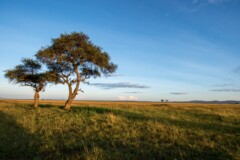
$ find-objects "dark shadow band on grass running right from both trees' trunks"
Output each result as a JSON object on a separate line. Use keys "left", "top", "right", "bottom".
{"left": 36, "top": 104, "right": 240, "bottom": 134}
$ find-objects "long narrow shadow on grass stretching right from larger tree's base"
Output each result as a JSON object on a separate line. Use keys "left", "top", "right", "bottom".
{"left": 71, "top": 107, "right": 240, "bottom": 134}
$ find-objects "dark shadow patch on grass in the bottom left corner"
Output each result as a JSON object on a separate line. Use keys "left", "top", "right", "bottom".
{"left": 0, "top": 112, "right": 38, "bottom": 160}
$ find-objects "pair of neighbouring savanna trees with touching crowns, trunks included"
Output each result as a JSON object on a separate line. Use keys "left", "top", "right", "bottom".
{"left": 5, "top": 32, "right": 117, "bottom": 109}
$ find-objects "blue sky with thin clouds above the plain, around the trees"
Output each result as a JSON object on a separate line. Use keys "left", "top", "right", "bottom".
{"left": 0, "top": 0, "right": 240, "bottom": 101}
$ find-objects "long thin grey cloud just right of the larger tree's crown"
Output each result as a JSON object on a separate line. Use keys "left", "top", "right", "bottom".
{"left": 90, "top": 82, "right": 150, "bottom": 89}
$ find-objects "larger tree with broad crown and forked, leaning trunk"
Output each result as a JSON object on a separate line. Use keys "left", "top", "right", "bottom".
{"left": 36, "top": 32, "right": 117, "bottom": 109}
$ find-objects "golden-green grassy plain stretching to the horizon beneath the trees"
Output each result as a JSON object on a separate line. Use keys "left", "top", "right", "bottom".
{"left": 0, "top": 100, "right": 240, "bottom": 160}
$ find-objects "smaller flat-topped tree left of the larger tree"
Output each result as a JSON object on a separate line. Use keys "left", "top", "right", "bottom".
{"left": 5, "top": 58, "right": 49, "bottom": 107}
